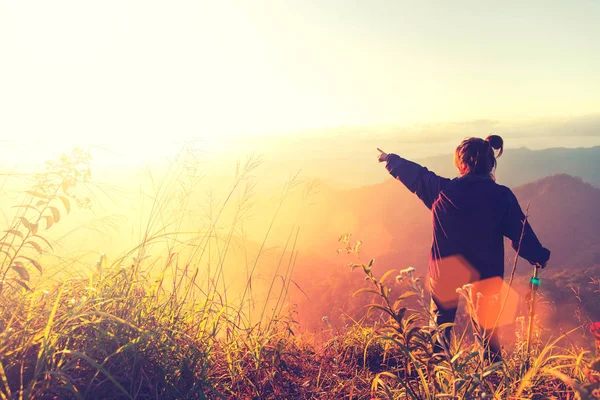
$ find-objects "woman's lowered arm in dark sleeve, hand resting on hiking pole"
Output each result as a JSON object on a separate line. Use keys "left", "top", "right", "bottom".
{"left": 502, "top": 188, "right": 550, "bottom": 267}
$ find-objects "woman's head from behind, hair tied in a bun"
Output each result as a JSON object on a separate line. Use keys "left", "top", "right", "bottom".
{"left": 454, "top": 135, "right": 504, "bottom": 176}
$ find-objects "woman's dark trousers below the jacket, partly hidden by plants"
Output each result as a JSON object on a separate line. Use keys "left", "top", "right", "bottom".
{"left": 431, "top": 295, "right": 502, "bottom": 362}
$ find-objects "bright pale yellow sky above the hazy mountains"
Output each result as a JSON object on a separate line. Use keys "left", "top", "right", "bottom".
{"left": 0, "top": 0, "right": 600, "bottom": 166}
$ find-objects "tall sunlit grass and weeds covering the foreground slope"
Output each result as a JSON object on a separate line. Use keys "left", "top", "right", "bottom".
{"left": 0, "top": 151, "right": 600, "bottom": 399}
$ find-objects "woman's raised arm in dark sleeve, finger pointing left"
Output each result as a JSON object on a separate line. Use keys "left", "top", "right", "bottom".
{"left": 377, "top": 149, "right": 450, "bottom": 210}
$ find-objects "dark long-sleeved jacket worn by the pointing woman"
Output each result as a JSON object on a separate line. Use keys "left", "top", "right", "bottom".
{"left": 386, "top": 154, "right": 550, "bottom": 279}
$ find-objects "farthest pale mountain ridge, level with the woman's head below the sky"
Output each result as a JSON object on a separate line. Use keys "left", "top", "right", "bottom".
{"left": 245, "top": 145, "right": 600, "bottom": 188}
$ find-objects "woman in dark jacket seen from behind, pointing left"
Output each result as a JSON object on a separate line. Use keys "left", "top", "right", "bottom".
{"left": 377, "top": 135, "right": 550, "bottom": 361}
